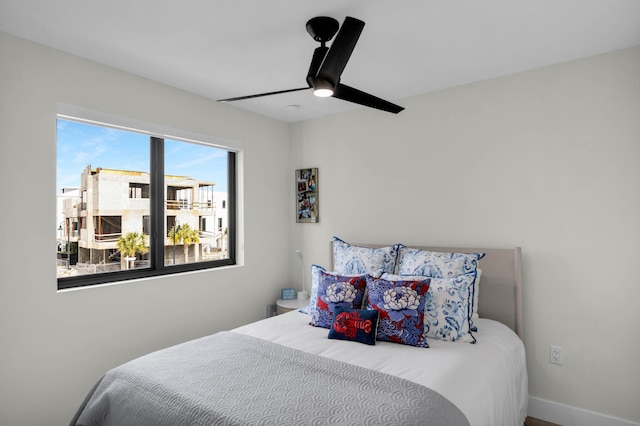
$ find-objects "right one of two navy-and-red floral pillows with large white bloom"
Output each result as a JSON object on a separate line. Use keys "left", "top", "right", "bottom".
{"left": 367, "top": 275, "right": 430, "bottom": 348}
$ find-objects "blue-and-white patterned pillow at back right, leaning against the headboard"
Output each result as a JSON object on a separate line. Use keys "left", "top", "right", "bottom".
{"left": 396, "top": 247, "right": 484, "bottom": 278}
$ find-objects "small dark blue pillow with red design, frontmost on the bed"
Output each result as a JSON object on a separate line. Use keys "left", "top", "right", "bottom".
{"left": 329, "top": 306, "right": 379, "bottom": 345}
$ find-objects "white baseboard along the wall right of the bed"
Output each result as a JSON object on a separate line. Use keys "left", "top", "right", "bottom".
{"left": 527, "top": 396, "right": 640, "bottom": 426}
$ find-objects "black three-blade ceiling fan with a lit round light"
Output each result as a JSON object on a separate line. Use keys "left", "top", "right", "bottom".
{"left": 218, "top": 16, "right": 404, "bottom": 114}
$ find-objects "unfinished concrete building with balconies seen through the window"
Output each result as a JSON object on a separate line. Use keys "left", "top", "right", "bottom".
{"left": 58, "top": 165, "right": 227, "bottom": 273}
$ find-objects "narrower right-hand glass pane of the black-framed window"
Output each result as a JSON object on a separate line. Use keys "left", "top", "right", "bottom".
{"left": 163, "top": 139, "right": 229, "bottom": 265}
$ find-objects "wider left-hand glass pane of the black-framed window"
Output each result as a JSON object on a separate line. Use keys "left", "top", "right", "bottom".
{"left": 56, "top": 119, "right": 150, "bottom": 278}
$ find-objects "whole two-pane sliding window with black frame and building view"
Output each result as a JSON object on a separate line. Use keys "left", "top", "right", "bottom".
{"left": 56, "top": 116, "right": 236, "bottom": 289}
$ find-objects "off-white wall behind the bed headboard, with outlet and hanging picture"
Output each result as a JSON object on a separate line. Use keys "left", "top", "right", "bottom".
{"left": 292, "top": 48, "right": 640, "bottom": 422}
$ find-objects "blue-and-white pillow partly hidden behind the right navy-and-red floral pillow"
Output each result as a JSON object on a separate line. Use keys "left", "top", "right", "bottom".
{"left": 381, "top": 273, "right": 478, "bottom": 343}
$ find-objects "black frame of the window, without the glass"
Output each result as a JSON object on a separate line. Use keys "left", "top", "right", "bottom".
{"left": 57, "top": 131, "right": 237, "bottom": 290}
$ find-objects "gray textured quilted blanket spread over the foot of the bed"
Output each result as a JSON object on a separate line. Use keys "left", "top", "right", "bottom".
{"left": 71, "top": 332, "right": 469, "bottom": 426}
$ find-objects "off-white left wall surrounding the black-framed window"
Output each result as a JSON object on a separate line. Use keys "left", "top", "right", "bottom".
{"left": 0, "top": 34, "right": 293, "bottom": 426}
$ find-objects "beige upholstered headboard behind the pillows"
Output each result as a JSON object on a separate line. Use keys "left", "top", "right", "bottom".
{"left": 331, "top": 244, "right": 524, "bottom": 340}
